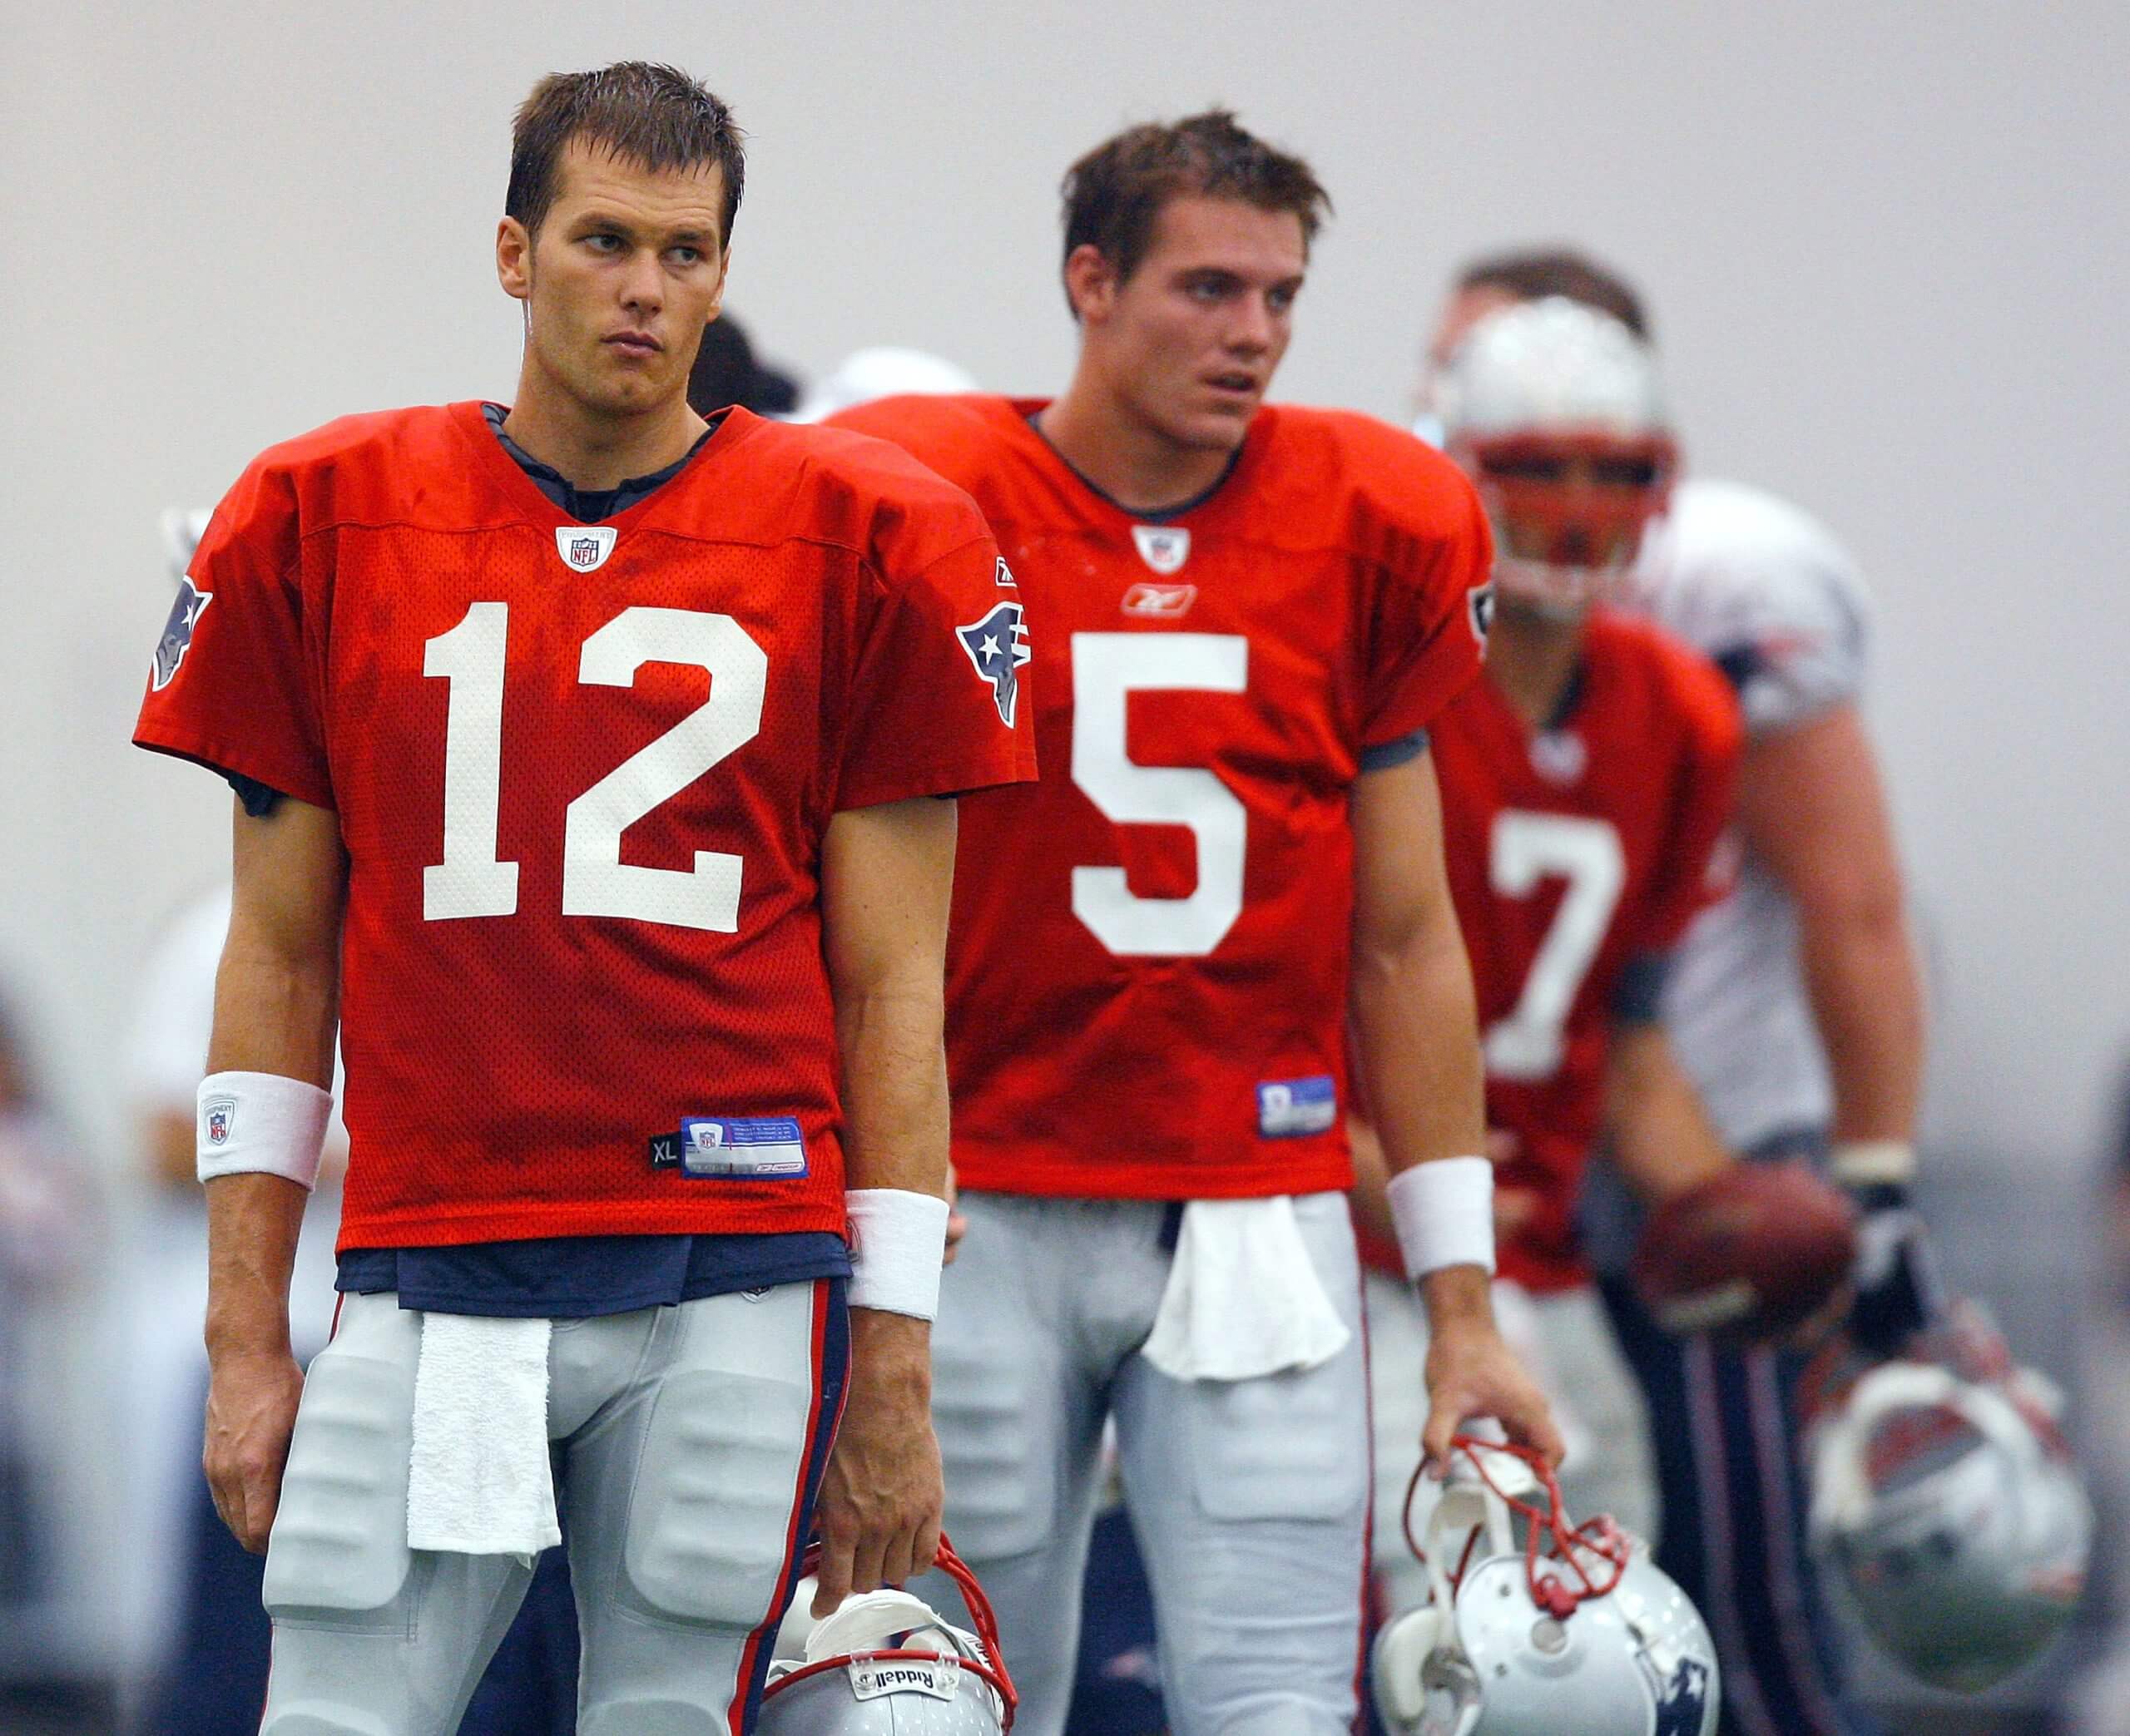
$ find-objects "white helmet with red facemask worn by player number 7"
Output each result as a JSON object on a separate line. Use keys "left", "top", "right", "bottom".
{"left": 1427, "top": 296, "right": 1678, "bottom": 618}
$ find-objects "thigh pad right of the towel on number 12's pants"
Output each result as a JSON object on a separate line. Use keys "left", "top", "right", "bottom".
{"left": 622, "top": 1370, "right": 814, "bottom": 1627}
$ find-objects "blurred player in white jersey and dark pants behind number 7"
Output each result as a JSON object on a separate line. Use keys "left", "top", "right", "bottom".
{"left": 1429, "top": 251, "right": 1934, "bottom": 1736}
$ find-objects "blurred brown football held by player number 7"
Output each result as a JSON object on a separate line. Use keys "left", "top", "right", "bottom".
{"left": 1632, "top": 1163, "right": 1857, "bottom": 1344}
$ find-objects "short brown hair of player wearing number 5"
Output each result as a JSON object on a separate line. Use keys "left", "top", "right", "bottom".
{"left": 1058, "top": 109, "right": 1331, "bottom": 315}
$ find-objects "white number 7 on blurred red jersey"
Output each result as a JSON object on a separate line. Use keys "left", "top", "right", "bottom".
{"left": 1487, "top": 809, "right": 1627, "bottom": 1080}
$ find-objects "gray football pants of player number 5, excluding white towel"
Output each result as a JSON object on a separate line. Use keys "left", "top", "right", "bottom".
{"left": 918, "top": 1193, "right": 1370, "bottom": 1736}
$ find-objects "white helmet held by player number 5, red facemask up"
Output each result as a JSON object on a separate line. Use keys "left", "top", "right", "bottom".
{"left": 1372, "top": 1436, "right": 1721, "bottom": 1736}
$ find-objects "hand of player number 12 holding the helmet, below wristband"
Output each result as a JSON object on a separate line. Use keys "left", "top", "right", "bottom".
{"left": 814, "top": 1308, "right": 946, "bottom": 1619}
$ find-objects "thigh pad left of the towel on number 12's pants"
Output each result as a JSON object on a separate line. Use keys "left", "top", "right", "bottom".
{"left": 264, "top": 1353, "right": 414, "bottom": 1619}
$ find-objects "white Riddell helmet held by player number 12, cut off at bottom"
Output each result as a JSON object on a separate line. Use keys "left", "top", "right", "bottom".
{"left": 754, "top": 1538, "right": 1016, "bottom": 1736}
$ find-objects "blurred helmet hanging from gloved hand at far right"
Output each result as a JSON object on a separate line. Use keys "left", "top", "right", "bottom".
{"left": 1806, "top": 1303, "right": 2093, "bottom": 1694}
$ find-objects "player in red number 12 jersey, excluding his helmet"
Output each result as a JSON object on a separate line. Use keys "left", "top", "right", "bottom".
{"left": 136, "top": 62, "right": 1033, "bottom": 1736}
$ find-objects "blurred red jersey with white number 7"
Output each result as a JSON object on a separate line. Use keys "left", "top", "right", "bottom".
{"left": 1435, "top": 613, "right": 1741, "bottom": 1291}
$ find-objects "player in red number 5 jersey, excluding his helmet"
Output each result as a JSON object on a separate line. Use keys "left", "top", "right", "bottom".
{"left": 835, "top": 113, "right": 1555, "bottom": 1736}
